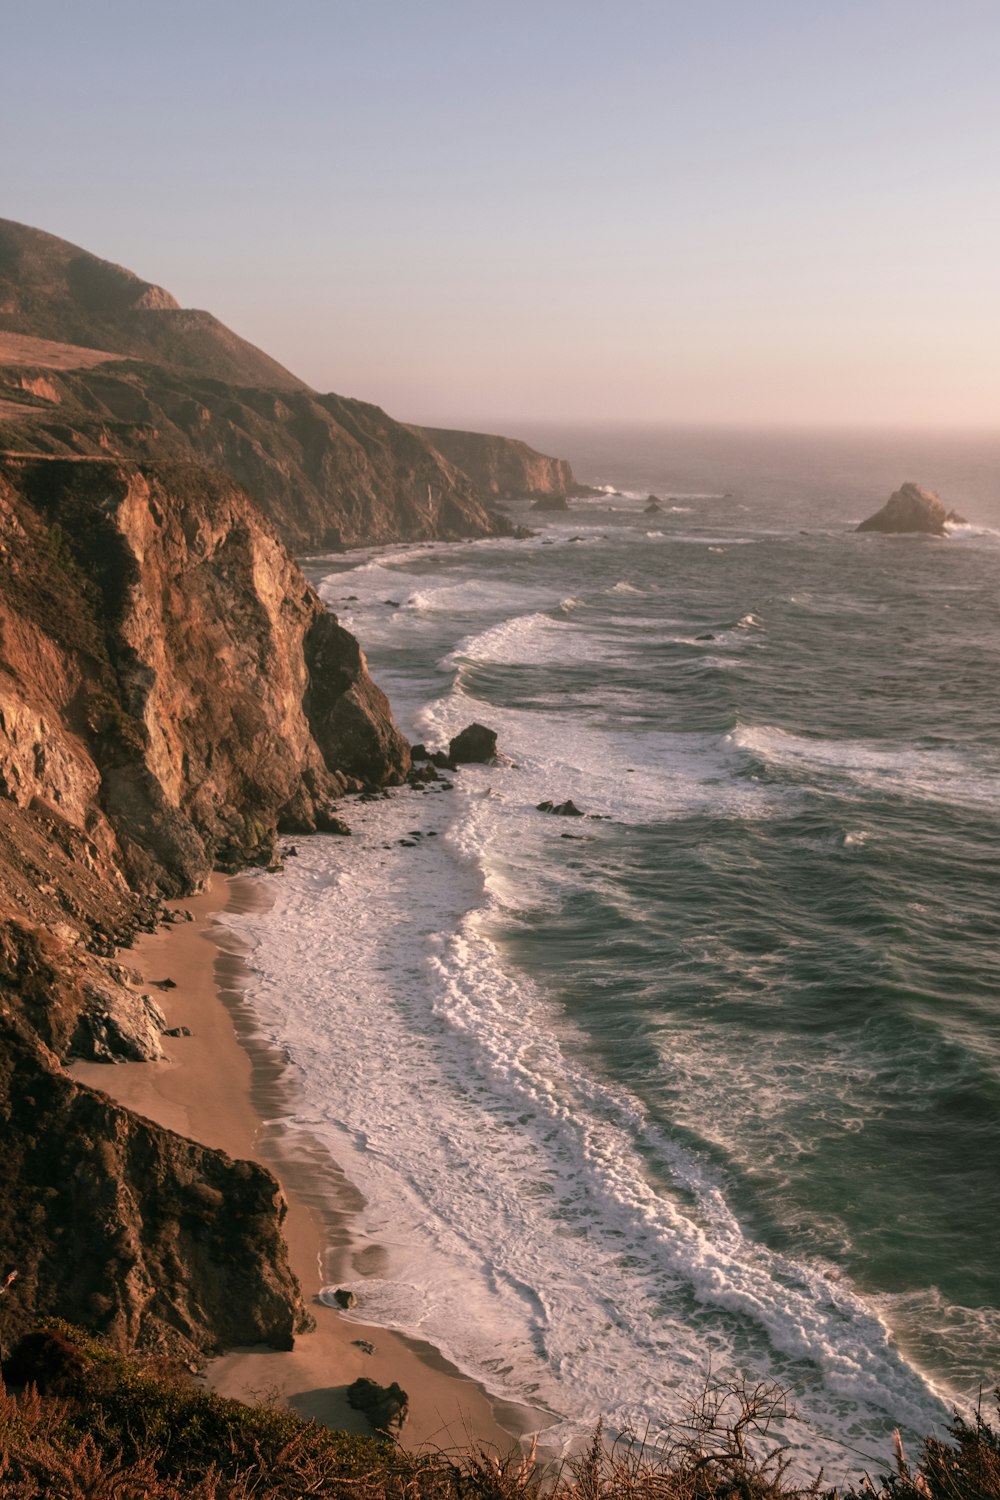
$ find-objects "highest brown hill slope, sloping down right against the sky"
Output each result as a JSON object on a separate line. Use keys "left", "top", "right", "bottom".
{"left": 0, "top": 219, "right": 306, "bottom": 390}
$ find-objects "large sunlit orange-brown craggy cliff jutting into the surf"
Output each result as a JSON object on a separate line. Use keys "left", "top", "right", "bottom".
{"left": 0, "top": 458, "right": 409, "bottom": 894}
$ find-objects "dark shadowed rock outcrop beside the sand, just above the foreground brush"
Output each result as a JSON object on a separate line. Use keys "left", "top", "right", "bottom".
{"left": 0, "top": 921, "right": 309, "bottom": 1358}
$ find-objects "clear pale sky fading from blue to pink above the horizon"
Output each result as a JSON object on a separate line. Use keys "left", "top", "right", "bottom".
{"left": 0, "top": 0, "right": 1000, "bottom": 428}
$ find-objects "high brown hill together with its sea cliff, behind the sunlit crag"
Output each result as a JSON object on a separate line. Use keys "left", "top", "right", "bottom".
{"left": 0, "top": 219, "right": 529, "bottom": 552}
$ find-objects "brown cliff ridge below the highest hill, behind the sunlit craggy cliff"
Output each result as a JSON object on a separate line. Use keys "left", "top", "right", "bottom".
{"left": 0, "top": 357, "right": 511, "bottom": 552}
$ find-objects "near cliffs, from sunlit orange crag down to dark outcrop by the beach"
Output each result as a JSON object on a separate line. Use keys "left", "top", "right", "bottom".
{"left": 0, "top": 455, "right": 409, "bottom": 1350}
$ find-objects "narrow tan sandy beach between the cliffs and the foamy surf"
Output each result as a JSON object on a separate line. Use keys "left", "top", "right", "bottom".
{"left": 72, "top": 875, "right": 550, "bottom": 1452}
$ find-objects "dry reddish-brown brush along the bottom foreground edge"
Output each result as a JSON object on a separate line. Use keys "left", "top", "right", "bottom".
{"left": 0, "top": 1326, "right": 1000, "bottom": 1500}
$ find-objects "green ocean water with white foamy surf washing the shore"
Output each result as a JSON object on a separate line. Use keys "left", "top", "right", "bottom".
{"left": 220, "top": 429, "right": 1000, "bottom": 1482}
